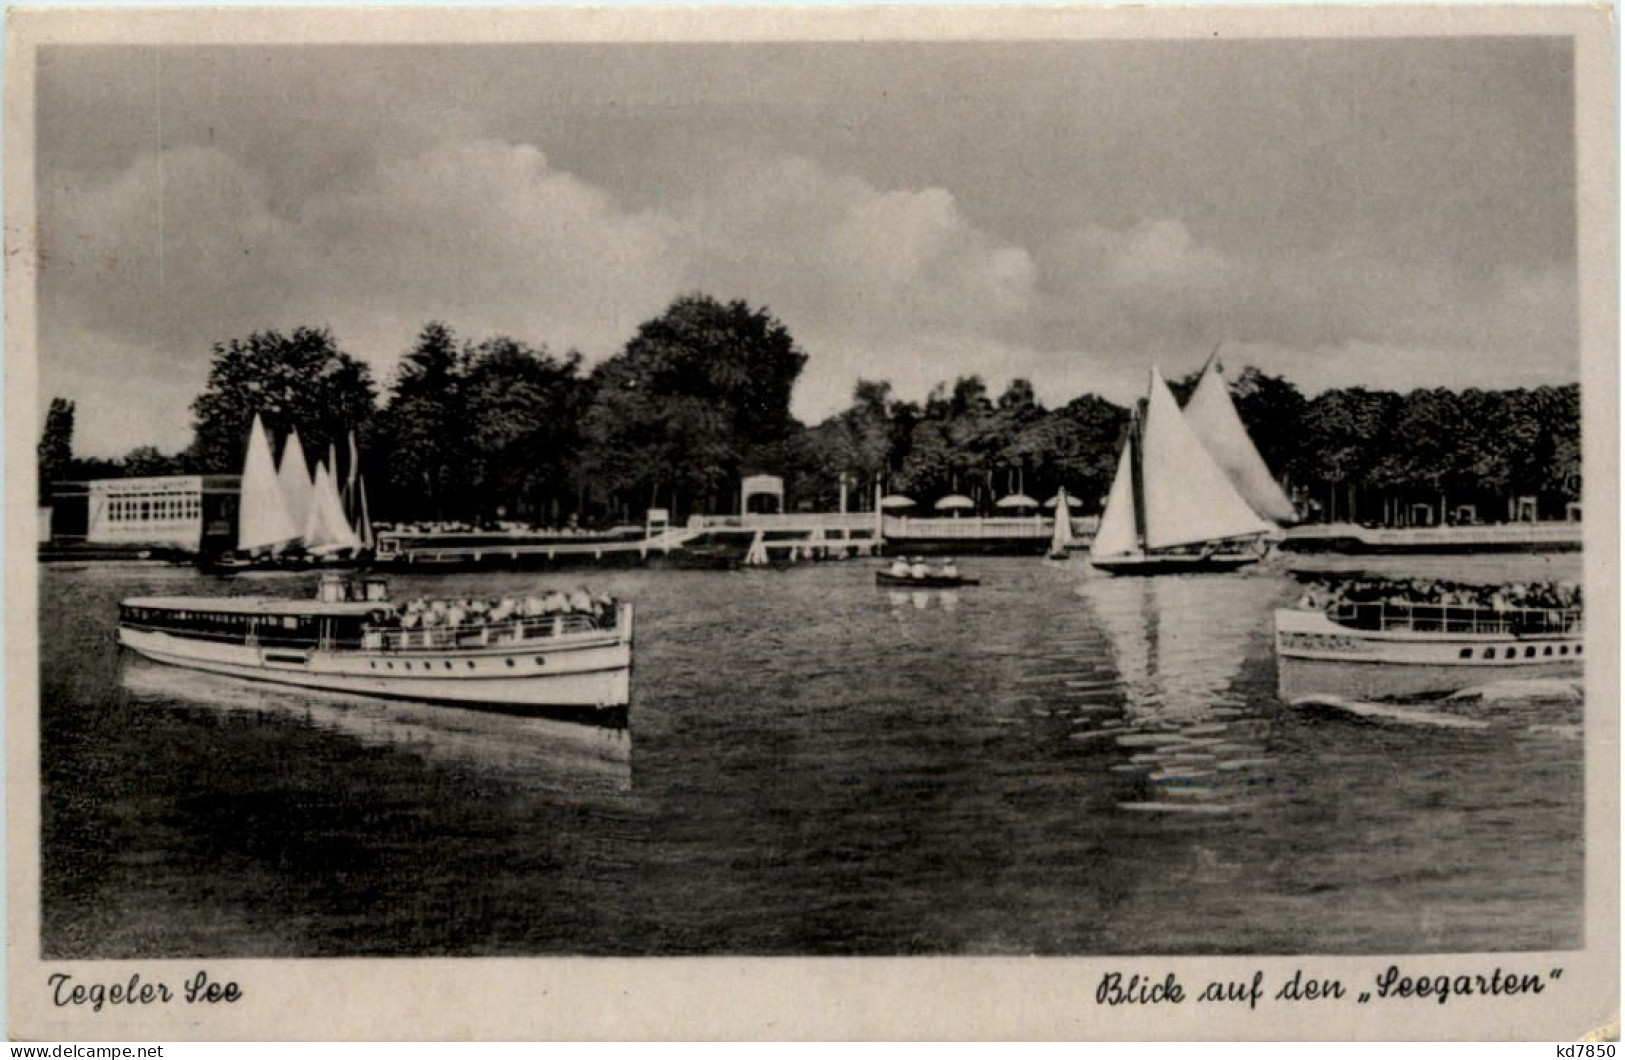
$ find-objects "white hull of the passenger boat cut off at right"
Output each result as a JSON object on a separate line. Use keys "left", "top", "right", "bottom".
{"left": 1276, "top": 611, "right": 1584, "bottom": 702}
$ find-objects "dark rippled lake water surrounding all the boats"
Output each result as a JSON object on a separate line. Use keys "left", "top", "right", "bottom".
{"left": 41, "top": 559, "right": 1584, "bottom": 959}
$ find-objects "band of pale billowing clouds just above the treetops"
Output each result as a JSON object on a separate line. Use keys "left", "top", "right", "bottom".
{"left": 41, "top": 135, "right": 1575, "bottom": 452}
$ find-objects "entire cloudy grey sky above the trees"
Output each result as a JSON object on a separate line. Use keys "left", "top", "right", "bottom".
{"left": 36, "top": 37, "right": 1580, "bottom": 455}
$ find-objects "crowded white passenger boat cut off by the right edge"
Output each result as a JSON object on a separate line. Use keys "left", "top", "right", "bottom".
{"left": 1276, "top": 603, "right": 1586, "bottom": 702}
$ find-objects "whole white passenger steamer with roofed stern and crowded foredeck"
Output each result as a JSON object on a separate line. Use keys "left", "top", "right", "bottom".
{"left": 119, "top": 574, "right": 632, "bottom": 712}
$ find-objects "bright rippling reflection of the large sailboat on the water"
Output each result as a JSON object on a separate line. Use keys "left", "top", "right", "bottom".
{"left": 1077, "top": 576, "right": 1274, "bottom": 813}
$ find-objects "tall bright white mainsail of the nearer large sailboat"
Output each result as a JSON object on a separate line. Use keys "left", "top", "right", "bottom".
{"left": 1141, "top": 367, "right": 1272, "bottom": 550}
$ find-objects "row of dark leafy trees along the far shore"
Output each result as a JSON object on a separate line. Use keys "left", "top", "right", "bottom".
{"left": 41, "top": 294, "right": 1580, "bottom": 523}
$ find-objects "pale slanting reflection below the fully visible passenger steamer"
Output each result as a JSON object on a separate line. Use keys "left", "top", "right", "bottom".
{"left": 120, "top": 657, "right": 632, "bottom": 795}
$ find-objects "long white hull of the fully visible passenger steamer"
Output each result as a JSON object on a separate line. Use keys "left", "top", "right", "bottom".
{"left": 119, "top": 608, "right": 632, "bottom": 712}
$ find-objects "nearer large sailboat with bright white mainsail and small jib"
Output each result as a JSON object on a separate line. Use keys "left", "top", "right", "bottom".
{"left": 1089, "top": 367, "right": 1274, "bottom": 574}
